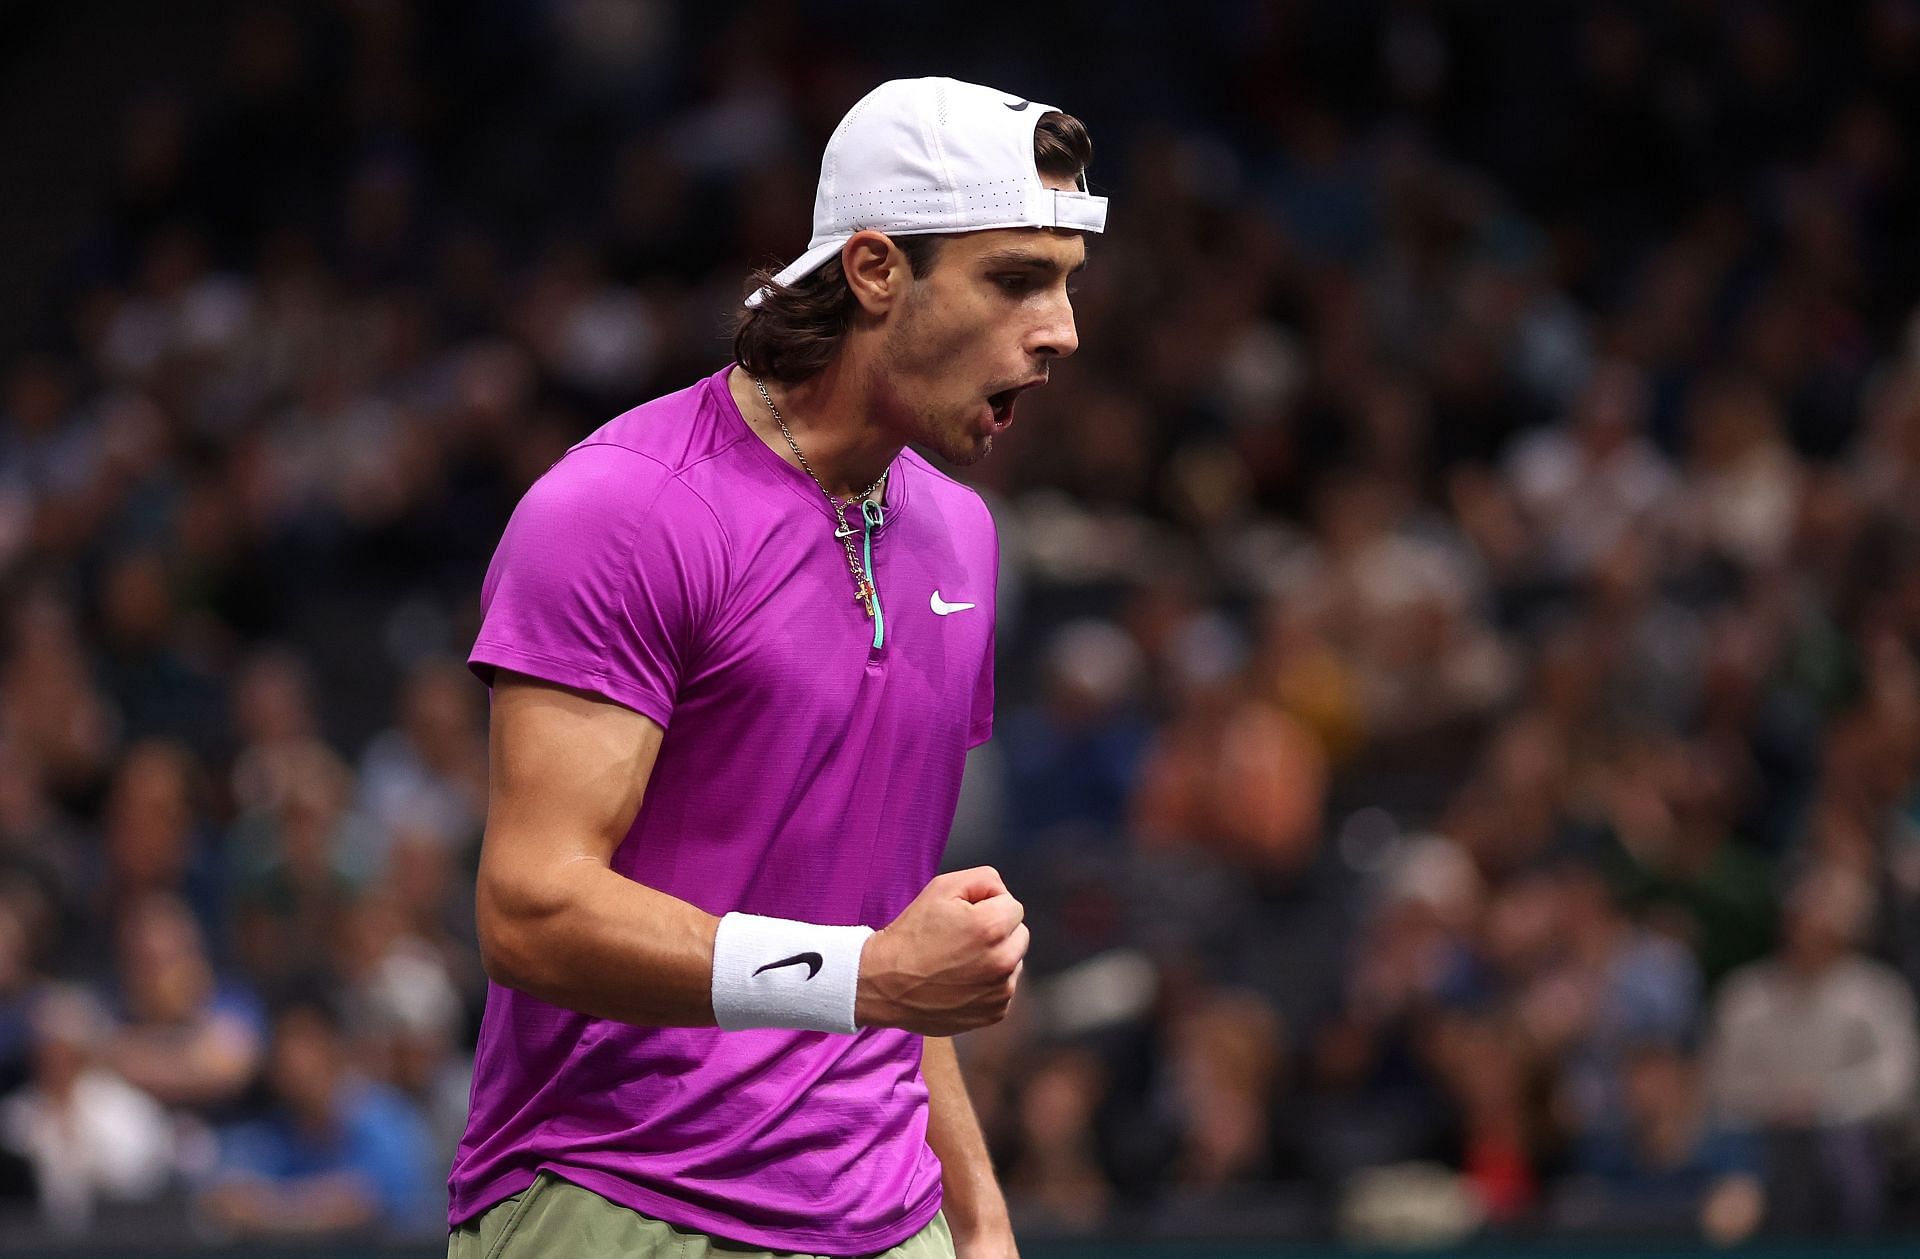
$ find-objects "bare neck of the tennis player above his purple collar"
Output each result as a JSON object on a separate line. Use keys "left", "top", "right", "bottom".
{"left": 728, "top": 355, "right": 904, "bottom": 499}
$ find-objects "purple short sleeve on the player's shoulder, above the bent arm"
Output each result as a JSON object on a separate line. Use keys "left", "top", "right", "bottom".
{"left": 468, "top": 445, "right": 726, "bottom": 725}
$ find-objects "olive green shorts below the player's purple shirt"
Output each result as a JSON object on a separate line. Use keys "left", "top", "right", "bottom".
{"left": 447, "top": 1171, "right": 954, "bottom": 1259}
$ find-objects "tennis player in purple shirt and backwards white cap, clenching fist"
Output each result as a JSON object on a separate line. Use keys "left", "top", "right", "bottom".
{"left": 449, "top": 79, "right": 1106, "bottom": 1259}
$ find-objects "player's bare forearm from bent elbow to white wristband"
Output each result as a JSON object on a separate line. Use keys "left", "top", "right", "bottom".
{"left": 480, "top": 860, "right": 720, "bottom": 1027}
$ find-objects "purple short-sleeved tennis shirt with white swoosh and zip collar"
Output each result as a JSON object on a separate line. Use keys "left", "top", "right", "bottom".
{"left": 449, "top": 370, "right": 998, "bottom": 1255}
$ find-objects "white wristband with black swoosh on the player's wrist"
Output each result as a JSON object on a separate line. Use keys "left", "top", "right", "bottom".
{"left": 714, "top": 914, "right": 874, "bottom": 1033}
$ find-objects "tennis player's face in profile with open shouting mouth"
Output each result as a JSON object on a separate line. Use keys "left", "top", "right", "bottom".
{"left": 872, "top": 180, "right": 1087, "bottom": 464}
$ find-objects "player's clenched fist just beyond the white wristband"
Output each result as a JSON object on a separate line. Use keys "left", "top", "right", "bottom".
{"left": 852, "top": 866, "right": 1027, "bottom": 1036}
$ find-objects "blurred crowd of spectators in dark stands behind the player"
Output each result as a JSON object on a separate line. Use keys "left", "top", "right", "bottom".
{"left": 0, "top": 0, "right": 1920, "bottom": 1242}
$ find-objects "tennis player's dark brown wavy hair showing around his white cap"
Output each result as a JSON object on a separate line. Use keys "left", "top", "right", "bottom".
{"left": 733, "top": 109, "right": 1092, "bottom": 384}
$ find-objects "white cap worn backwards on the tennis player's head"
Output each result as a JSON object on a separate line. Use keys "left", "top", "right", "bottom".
{"left": 747, "top": 79, "right": 1106, "bottom": 305}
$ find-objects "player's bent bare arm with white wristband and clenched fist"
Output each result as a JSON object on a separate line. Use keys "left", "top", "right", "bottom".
{"left": 474, "top": 674, "right": 1027, "bottom": 1036}
